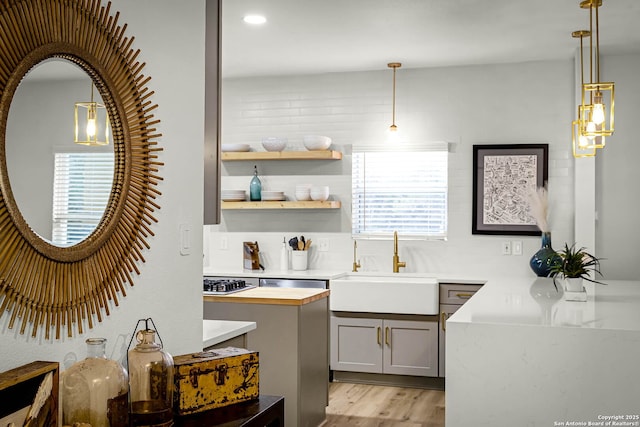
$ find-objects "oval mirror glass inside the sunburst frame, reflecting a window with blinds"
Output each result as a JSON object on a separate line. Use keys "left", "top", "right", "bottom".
{"left": 5, "top": 58, "right": 114, "bottom": 247}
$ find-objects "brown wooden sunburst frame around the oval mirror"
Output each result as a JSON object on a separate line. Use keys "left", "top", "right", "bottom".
{"left": 0, "top": 0, "right": 162, "bottom": 339}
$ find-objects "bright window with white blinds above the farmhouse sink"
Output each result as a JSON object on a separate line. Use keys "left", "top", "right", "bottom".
{"left": 351, "top": 149, "right": 447, "bottom": 238}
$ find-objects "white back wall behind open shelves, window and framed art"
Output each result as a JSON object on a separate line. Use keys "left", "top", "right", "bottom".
{"left": 204, "top": 60, "right": 575, "bottom": 277}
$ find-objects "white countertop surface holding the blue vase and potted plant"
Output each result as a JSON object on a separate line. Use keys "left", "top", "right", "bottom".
{"left": 447, "top": 278, "right": 640, "bottom": 331}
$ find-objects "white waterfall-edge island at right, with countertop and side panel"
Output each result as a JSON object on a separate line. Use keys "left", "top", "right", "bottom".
{"left": 446, "top": 278, "right": 640, "bottom": 427}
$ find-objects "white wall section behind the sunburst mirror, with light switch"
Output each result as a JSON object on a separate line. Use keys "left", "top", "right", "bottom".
{"left": 0, "top": 0, "right": 205, "bottom": 371}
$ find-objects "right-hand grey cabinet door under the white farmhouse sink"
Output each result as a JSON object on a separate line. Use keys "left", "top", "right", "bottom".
{"left": 383, "top": 320, "right": 438, "bottom": 377}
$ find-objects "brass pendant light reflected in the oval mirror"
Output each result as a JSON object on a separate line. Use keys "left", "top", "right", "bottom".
{"left": 74, "top": 82, "right": 110, "bottom": 146}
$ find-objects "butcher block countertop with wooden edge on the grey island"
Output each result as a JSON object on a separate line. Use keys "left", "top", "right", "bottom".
{"left": 204, "top": 287, "right": 329, "bottom": 305}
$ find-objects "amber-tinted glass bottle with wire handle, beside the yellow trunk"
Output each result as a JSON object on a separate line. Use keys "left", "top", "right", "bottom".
{"left": 128, "top": 319, "right": 173, "bottom": 427}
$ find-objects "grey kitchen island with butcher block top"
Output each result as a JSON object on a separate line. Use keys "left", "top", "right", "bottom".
{"left": 204, "top": 288, "right": 329, "bottom": 427}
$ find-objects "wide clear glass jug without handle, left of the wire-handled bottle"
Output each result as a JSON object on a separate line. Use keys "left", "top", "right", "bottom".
{"left": 61, "top": 338, "right": 129, "bottom": 427}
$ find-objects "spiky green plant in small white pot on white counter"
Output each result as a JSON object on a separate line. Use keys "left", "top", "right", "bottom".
{"left": 550, "top": 243, "right": 604, "bottom": 292}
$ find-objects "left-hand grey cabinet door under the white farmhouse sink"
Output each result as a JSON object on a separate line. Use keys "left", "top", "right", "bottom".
{"left": 331, "top": 316, "right": 383, "bottom": 373}
